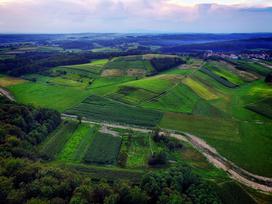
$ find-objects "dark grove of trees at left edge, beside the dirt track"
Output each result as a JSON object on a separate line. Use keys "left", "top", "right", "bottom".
{"left": 0, "top": 97, "right": 61, "bottom": 159}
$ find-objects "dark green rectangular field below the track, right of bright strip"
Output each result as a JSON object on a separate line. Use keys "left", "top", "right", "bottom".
{"left": 83, "top": 133, "right": 122, "bottom": 164}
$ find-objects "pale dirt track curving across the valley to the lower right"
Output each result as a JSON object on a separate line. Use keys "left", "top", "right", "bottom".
{"left": 62, "top": 114, "right": 272, "bottom": 193}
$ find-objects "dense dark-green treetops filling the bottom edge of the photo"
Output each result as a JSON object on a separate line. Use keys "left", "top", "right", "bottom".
{"left": 0, "top": 157, "right": 221, "bottom": 204}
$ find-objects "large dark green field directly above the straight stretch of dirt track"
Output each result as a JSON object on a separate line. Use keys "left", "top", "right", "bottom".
{"left": 66, "top": 95, "right": 162, "bottom": 127}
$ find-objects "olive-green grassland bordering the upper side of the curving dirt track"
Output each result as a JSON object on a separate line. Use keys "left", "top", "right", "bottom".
{"left": 160, "top": 113, "right": 272, "bottom": 176}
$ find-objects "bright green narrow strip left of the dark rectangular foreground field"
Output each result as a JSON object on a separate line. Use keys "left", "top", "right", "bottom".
{"left": 57, "top": 124, "right": 95, "bottom": 161}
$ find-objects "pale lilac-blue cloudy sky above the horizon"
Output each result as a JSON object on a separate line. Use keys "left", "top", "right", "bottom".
{"left": 0, "top": 0, "right": 272, "bottom": 33}
